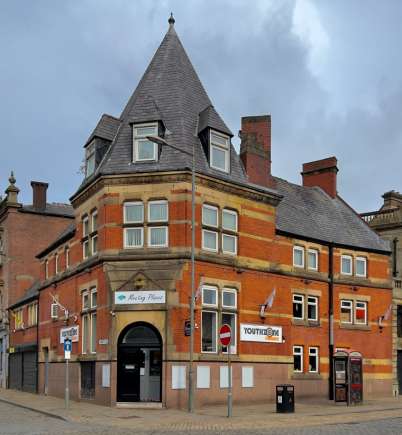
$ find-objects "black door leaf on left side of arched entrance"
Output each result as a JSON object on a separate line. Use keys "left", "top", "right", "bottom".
{"left": 117, "top": 347, "right": 145, "bottom": 402}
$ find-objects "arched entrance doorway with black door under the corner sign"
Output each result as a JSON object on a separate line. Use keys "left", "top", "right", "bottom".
{"left": 117, "top": 322, "right": 162, "bottom": 402}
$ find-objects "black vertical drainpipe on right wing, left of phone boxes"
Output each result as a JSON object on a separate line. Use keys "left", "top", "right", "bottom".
{"left": 328, "top": 242, "right": 334, "bottom": 400}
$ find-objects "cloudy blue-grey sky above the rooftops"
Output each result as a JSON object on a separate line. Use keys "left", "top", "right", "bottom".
{"left": 0, "top": 0, "right": 402, "bottom": 211}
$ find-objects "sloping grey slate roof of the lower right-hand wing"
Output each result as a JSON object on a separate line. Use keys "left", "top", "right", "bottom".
{"left": 274, "top": 177, "right": 390, "bottom": 252}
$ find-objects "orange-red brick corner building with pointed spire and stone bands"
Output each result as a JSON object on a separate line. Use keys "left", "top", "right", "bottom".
{"left": 9, "top": 18, "right": 392, "bottom": 407}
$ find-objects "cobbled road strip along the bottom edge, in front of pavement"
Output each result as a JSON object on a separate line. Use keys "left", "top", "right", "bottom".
{"left": 0, "top": 403, "right": 402, "bottom": 435}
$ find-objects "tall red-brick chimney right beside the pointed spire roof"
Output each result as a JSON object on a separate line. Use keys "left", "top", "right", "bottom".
{"left": 240, "top": 115, "right": 274, "bottom": 187}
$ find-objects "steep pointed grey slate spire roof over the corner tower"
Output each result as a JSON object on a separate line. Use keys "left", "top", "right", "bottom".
{"left": 72, "top": 19, "right": 275, "bottom": 198}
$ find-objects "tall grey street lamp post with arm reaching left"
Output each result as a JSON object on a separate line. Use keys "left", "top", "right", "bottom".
{"left": 147, "top": 136, "right": 195, "bottom": 412}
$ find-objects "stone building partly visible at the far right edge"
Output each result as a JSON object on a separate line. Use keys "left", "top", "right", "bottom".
{"left": 362, "top": 190, "right": 402, "bottom": 394}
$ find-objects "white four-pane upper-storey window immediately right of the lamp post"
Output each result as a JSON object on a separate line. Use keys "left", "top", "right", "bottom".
{"left": 202, "top": 204, "right": 238, "bottom": 255}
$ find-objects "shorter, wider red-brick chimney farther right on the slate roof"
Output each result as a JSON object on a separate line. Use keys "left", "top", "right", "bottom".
{"left": 301, "top": 157, "right": 338, "bottom": 198}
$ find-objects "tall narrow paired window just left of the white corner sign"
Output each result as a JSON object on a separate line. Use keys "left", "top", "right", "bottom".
{"left": 81, "top": 287, "right": 98, "bottom": 354}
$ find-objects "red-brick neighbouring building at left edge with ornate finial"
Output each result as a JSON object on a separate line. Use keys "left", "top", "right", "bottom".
{"left": 0, "top": 174, "right": 73, "bottom": 390}
